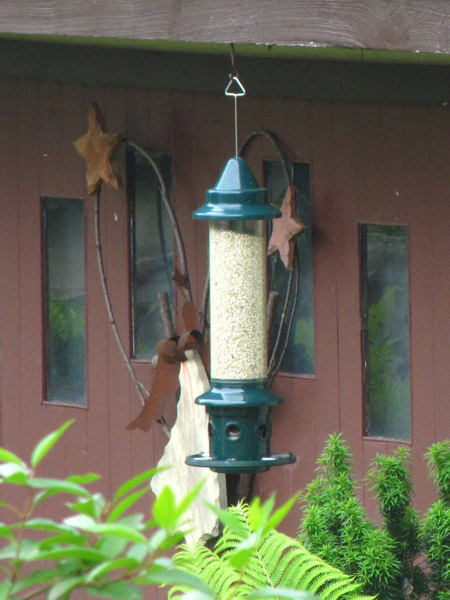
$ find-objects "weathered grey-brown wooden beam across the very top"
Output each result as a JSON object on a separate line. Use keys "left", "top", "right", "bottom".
{"left": 0, "top": 0, "right": 450, "bottom": 53}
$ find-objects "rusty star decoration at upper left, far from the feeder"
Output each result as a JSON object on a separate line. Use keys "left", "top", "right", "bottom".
{"left": 74, "top": 102, "right": 122, "bottom": 194}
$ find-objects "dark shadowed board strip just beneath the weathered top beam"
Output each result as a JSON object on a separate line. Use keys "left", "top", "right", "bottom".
{"left": 0, "top": 40, "right": 450, "bottom": 104}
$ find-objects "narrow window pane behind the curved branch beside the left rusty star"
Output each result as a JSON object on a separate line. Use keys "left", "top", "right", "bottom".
{"left": 128, "top": 152, "right": 174, "bottom": 359}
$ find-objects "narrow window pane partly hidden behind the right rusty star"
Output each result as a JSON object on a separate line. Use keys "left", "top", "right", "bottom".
{"left": 264, "top": 161, "right": 316, "bottom": 375}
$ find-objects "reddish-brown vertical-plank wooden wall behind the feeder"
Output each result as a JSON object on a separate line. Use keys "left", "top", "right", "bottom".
{"left": 0, "top": 79, "right": 450, "bottom": 552}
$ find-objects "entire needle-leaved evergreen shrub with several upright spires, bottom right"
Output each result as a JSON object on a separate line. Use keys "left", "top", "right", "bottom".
{"left": 299, "top": 435, "right": 450, "bottom": 600}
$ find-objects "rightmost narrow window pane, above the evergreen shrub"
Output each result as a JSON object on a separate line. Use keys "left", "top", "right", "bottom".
{"left": 361, "top": 225, "right": 411, "bottom": 440}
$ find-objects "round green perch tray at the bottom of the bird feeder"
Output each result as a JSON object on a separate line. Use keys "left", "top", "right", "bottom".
{"left": 186, "top": 452, "right": 296, "bottom": 473}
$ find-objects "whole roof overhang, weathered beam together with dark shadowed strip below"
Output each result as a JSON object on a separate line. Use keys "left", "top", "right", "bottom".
{"left": 0, "top": 0, "right": 450, "bottom": 104}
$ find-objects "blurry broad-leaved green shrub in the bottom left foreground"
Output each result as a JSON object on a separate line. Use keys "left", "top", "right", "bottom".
{"left": 0, "top": 422, "right": 312, "bottom": 600}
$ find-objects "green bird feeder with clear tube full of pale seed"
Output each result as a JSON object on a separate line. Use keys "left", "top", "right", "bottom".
{"left": 186, "top": 157, "right": 295, "bottom": 473}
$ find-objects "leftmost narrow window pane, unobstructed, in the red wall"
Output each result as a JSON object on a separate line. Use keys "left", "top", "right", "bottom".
{"left": 43, "top": 198, "right": 86, "bottom": 405}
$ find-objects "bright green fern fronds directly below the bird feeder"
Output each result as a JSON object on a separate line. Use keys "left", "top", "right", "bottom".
{"left": 170, "top": 499, "right": 370, "bottom": 600}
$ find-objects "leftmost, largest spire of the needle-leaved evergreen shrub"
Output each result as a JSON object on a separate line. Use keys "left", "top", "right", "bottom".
{"left": 299, "top": 435, "right": 402, "bottom": 600}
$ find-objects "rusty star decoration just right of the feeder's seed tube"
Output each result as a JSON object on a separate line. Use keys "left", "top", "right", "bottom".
{"left": 267, "top": 185, "right": 306, "bottom": 271}
